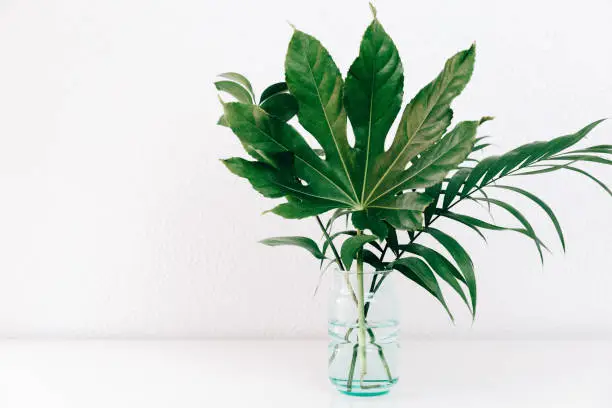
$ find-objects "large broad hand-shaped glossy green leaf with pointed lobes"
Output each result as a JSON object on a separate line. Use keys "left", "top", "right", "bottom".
{"left": 221, "top": 13, "right": 482, "bottom": 230}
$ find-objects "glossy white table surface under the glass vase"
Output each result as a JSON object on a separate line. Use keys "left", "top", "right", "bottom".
{"left": 0, "top": 340, "right": 612, "bottom": 408}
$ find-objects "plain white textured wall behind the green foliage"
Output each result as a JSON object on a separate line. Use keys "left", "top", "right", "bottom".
{"left": 0, "top": 0, "right": 612, "bottom": 338}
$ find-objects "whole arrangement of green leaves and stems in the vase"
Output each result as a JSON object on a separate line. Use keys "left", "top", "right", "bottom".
{"left": 217, "top": 3, "right": 612, "bottom": 390}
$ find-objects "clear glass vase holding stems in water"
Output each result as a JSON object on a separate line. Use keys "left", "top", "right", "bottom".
{"left": 328, "top": 265, "right": 399, "bottom": 396}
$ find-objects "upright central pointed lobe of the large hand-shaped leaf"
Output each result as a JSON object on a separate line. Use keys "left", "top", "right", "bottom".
{"left": 344, "top": 14, "right": 404, "bottom": 202}
